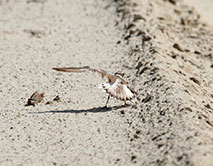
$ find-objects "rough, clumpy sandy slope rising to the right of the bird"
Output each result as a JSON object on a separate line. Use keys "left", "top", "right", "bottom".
{"left": 117, "top": 0, "right": 213, "bottom": 166}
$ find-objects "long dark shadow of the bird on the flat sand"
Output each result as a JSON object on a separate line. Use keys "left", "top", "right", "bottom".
{"left": 30, "top": 105, "right": 131, "bottom": 114}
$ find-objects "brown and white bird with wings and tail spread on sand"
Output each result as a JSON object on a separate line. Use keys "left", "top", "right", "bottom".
{"left": 52, "top": 66, "right": 138, "bottom": 108}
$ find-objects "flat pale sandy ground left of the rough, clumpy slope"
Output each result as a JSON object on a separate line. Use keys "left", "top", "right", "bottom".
{"left": 0, "top": 0, "right": 134, "bottom": 165}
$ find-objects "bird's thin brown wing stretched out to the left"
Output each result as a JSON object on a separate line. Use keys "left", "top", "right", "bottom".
{"left": 52, "top": 66, "right": 107, "bottom": 78}
